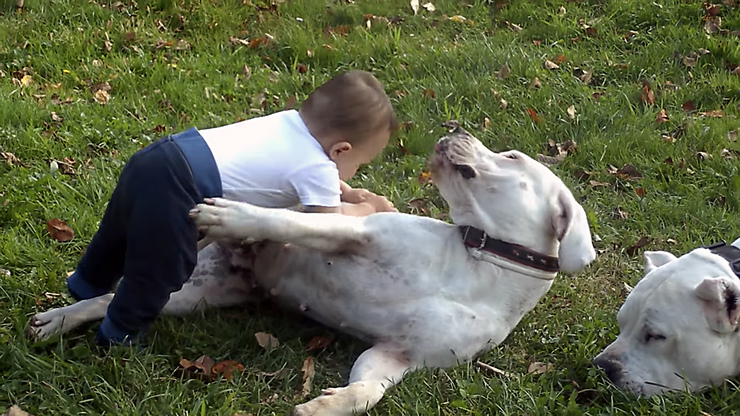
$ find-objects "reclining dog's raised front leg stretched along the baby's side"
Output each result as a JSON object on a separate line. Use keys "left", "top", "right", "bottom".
{"left": 190, "top": 198, "right": 370, "bottom": 252}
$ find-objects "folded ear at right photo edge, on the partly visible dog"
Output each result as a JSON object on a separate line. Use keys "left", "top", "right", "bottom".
{"left": 694, "top": 277, "right": 740, "bottom": 333}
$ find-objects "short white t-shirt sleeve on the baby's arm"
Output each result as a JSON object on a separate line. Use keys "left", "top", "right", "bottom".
{"left": 289, "top": 163, "right": 341, "bottom": 207}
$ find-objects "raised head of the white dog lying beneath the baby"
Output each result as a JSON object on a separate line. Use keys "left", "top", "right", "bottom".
{"left": 430, "top": 122, "right": 596, "bottom": 273}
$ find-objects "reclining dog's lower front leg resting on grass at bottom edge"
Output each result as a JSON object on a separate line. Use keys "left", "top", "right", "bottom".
{"left": 291, "top": 345, "right": 414, "bottom": 416}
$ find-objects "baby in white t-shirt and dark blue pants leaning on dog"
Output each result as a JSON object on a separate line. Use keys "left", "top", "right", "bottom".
{"left": 67, "top": 71, "right": 397, "bottom": 346}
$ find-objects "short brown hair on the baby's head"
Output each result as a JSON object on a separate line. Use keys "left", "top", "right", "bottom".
{"left": 300, "top": 70, "right": 398, "bottom": 145}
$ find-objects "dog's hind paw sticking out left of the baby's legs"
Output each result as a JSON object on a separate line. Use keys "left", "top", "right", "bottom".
{"left": 26, "top": 293, "right": 113, "bottom": 341}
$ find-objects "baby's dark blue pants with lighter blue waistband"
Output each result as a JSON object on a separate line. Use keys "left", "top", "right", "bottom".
{"left": 67, "top": 128, "right": 222, "bottom": 345}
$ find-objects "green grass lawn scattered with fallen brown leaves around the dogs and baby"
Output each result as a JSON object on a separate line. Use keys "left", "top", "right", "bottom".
{"left": 0, "top": 0, "right": 740, "bottom": 416}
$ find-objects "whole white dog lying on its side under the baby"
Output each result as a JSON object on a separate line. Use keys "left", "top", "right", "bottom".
{"left": 32, "top": 123, "right": 595, "bottom": 416}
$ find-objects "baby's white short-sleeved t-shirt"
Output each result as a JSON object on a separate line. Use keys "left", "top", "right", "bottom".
{"left": 199, "top": 110, "right": 340, "bottom": 208}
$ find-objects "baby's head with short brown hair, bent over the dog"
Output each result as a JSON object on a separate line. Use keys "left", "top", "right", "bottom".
{"left": 300, "top": 71, "right": 398, "bottom": 180}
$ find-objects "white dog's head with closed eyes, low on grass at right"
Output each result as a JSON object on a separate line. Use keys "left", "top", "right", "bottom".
{"left": 594, "top": 240, "right": 740, "bottom": 396}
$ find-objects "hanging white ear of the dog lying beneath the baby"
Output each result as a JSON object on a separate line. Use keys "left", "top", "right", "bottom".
{"left": 552, "top": 188, "right": 596, "bottom": 273}
